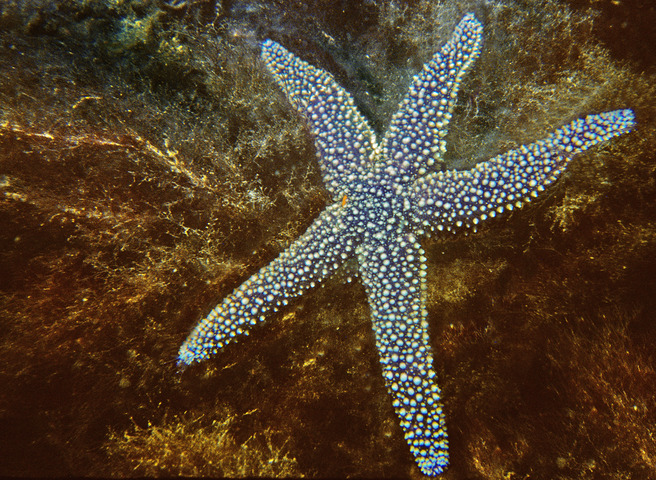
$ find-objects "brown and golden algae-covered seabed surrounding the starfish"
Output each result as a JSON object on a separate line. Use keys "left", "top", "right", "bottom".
{"left": 0, "top": 1, "right": 656, "bottom": 479}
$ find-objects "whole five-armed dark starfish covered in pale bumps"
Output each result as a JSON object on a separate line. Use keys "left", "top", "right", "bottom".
{"left": 178, "top": 14, "right": 634, "bottom": 475}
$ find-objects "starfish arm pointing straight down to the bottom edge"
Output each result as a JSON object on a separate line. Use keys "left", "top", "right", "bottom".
{"left": 357, "top": 234, "right": 449, "bottom": 475}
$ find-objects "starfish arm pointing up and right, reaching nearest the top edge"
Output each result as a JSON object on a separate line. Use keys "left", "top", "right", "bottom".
{"left": 382, "top": 13, "right": 483, "bottom": 183}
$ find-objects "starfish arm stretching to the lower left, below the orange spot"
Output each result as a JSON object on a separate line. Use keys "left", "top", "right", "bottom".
{"left": 178, "top": 204, "right": 355, "bottom": 367}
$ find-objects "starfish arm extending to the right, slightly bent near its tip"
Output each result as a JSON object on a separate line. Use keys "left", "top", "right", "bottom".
{"left": 408, "top": 110, "right": 635, "bottom": 236}
